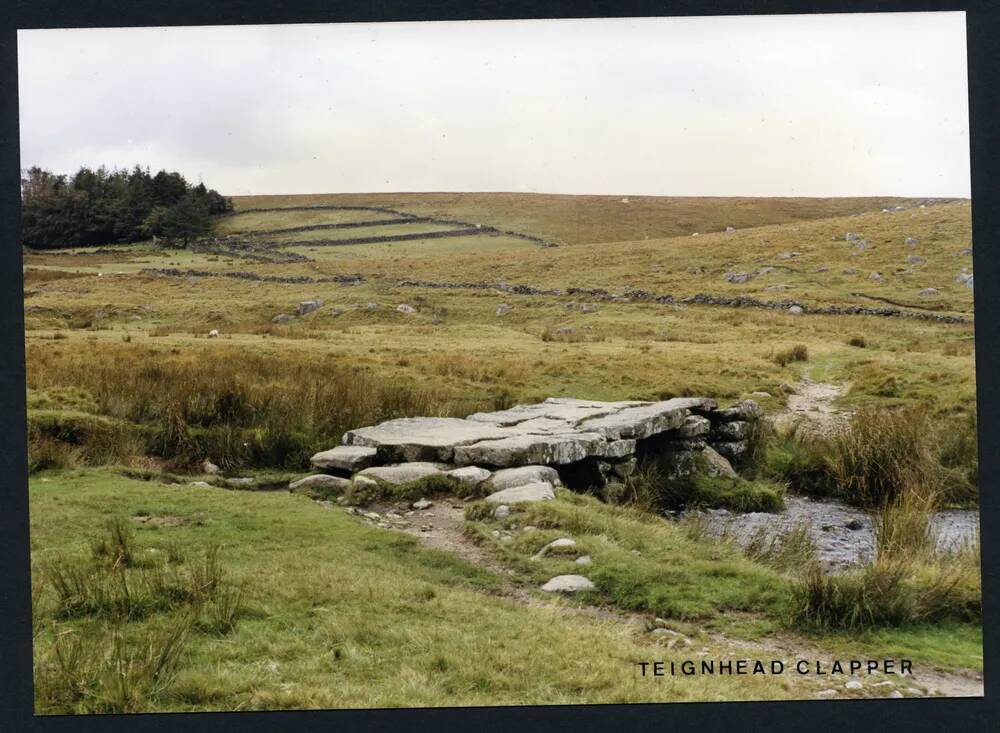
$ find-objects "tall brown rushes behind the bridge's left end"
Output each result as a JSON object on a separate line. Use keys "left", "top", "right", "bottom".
{"left": 28, "top": 344, "right": 488, "bottom": 469}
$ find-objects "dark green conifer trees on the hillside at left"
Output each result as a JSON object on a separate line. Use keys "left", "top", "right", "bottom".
{"left": 21, "top": 166, "right": 233, "bottom": 249}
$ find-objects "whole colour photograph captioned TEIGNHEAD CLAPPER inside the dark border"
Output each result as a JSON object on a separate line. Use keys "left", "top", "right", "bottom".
{"left": 17, "top": 11, "right": 990, "bottom": 717}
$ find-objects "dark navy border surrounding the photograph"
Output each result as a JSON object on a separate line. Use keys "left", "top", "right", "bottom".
{"left": 0, "top": 0, "right": 1000, "bottom": 733}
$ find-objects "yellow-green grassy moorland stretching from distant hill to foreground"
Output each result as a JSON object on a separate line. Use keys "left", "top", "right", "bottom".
{"left": 24, "top": 194, "right": 982, "bottom": 712}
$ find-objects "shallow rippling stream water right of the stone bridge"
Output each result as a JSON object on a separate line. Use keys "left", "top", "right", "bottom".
{"left": 680, "top": 496, "right": 979, "bottom": 570}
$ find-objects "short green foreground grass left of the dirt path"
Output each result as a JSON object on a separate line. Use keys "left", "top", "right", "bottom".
{"left": 30, "top": 470, "right": 832, "bottom": 712}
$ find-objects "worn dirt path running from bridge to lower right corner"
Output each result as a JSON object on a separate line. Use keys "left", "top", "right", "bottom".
{"left": 348, "top": 498, "right": 983, "bottom": 698}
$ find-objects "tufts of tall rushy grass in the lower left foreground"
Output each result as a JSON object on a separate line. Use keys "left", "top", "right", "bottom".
{"left": 32, "top": 517, "right": 245, "bottom": 713}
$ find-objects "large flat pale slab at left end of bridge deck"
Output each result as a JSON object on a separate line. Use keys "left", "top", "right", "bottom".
{"left": 344, "top": 417, "right": 510, "bottom": 463}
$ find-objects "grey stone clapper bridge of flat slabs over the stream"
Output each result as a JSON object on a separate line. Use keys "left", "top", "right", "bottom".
{"left": 300, "top": 397, "right": 761, "bottom": 592}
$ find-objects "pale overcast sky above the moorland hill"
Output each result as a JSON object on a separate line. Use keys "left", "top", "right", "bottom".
{"left": 18, "top": 13, "right": 969, "bottom": 196}
